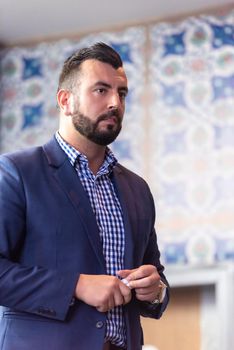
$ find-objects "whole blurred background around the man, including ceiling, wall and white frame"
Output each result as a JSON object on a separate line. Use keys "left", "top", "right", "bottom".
{"left": 0, "top": 0, "right": 234, "bottom": 350}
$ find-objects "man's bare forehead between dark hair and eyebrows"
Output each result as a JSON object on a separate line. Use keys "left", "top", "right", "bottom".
{"left": 80, "top": 59, "right": 127, "bottom": 86}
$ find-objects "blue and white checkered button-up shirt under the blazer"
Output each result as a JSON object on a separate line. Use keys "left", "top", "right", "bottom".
{"left": 55, "top": 132, "right": 126, "bottom": 347}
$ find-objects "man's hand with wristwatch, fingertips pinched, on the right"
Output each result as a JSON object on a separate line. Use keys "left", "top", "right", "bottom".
{"left": 117, "top": 265, "right": 160, "bottom": 302}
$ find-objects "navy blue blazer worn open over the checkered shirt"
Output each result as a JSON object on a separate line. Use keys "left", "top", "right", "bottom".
{"left": 0, "top": 138, "right": 168, "bottom": 350}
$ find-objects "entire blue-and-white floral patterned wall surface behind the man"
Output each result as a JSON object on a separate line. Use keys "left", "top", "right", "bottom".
{"left": 0, "top": 11, "right": 234, "bottom": 264}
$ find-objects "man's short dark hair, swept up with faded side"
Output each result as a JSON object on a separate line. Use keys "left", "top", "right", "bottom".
{"left": 58, "top": 42, "right": 123, "bottom": 90}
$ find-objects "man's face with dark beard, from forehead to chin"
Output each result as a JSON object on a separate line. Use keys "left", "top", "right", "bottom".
{"left": 71, "top": 60, "right": 128, "bottom": 146}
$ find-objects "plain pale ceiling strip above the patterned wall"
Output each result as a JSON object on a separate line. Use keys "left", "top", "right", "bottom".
{"left": 0, "top": 0, "right": 234, "bottom": 44}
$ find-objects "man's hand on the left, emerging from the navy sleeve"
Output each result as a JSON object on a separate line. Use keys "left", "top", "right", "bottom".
{"left": 75, "top": 274, "right": 132, "bottom": 312}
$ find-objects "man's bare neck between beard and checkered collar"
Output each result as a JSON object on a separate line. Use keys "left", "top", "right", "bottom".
{"left": 59, "top": 128, "right": 106, "bottom": 175}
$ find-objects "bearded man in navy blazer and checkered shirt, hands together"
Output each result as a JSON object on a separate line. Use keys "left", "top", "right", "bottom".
{"left": 0, "top": 43, "right": 168, "bottom": 350}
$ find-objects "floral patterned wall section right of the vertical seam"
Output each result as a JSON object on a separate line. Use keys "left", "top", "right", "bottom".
{"left": 150, "top": 9, "right": 234, "bottom": 264}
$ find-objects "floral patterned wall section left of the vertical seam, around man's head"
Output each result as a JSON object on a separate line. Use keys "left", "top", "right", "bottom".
{"left": 0, "top": 28, "right": 145, "bottom": 173}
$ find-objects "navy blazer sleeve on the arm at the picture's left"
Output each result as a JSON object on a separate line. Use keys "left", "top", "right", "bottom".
{"left": 0, "top": 156, "right": 79, "bottom": 320}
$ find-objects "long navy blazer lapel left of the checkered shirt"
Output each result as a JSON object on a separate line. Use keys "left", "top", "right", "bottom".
{"left": 43, "top": 139, "right": 105, "bottom": 273}
